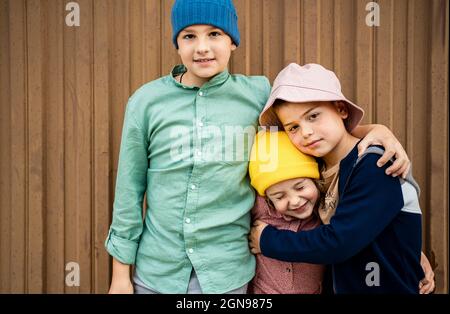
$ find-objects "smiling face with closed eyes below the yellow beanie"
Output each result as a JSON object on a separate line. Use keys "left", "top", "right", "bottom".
{"left": 266, "top": 178, "right": 319, "bottom": 219}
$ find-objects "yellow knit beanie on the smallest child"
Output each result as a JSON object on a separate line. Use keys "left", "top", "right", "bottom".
{"left": 249, "top": 131, "right": 320, "bottom": 196}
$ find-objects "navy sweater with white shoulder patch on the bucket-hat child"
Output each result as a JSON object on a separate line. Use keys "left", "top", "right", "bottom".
{"left": 260, "top": 146, "right": 424, "bottom": 293}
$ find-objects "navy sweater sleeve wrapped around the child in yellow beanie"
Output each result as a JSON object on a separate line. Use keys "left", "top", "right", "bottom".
{"left": 260, "top": 154, "right": 403, "bottom": 264}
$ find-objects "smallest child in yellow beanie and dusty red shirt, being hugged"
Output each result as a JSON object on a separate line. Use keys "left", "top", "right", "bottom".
{"left": 249, "top": 131, "right": 325, "bottom": 294}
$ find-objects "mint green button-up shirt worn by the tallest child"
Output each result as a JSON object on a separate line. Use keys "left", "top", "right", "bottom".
{"left": 105, "top": 66, "right": 270, "bottom": 293}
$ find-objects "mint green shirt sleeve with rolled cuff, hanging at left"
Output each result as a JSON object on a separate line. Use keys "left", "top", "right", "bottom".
{"left": 105, "top": 98, "right": 148, "bottom": 264}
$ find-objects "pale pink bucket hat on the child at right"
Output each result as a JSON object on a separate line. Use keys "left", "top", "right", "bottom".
{"left": 259, "top": 63, "right": 364, "bottom": 132}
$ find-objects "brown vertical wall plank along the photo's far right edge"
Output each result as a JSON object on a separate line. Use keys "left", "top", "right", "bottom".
{"left": 427, "top": 0, "right": 449, "bottom": 293}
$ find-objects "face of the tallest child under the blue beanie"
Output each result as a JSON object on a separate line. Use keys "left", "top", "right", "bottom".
{"left": 177, "top": 25, "right": 236, "bottom": 86}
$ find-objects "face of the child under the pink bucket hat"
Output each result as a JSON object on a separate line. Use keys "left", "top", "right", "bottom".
{"left": 275, "top": 101, "right": 348, "bottom": 162}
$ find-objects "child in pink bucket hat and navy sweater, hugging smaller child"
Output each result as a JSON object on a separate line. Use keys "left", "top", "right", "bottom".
{"left": 250, "top": 64, "right": 432, "bottom": 294}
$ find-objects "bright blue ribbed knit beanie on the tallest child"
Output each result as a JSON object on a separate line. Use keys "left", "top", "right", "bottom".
{"left": 172, "top": 0, "right": 241, "bottom": 49}
